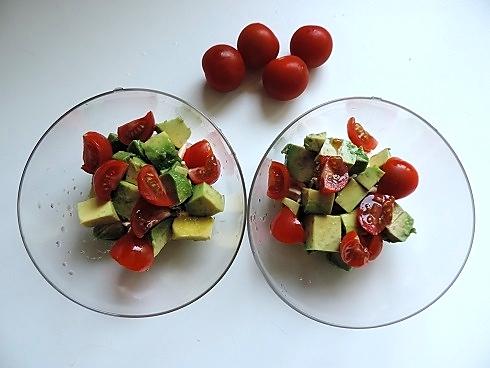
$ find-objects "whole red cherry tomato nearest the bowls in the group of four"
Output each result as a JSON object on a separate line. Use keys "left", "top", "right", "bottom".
{"left": 262, "top": 55, "right": 309, "bottom": 101}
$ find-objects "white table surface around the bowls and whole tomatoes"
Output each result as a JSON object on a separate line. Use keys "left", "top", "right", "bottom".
{"left": 0, "top": 0, "right": 490, "bottom": 368}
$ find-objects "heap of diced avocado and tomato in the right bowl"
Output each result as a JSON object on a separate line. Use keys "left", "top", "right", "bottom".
{"left": 267, "top": 117, "right": 418, "bottom": 271}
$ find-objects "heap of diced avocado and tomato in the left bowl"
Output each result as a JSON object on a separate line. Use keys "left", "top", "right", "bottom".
{"left": 77, "top": 111, "right": 225, "bottom": 272}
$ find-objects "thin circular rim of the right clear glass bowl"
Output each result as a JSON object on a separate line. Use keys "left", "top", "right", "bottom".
{"left": 247, "top": 96, "right": 476, "bottom": 330}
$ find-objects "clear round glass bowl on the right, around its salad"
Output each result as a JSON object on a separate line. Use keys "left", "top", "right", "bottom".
{"left": 247, "top": 98, "right": 475, "bottom": 328}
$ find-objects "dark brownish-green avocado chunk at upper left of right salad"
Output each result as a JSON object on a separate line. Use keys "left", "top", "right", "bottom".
{"left": 281, "top": 144, "right": 315, "bottom": 183}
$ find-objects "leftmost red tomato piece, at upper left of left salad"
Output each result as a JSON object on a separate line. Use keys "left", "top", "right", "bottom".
{"left": 82, "top": 132, "right": 112, "bottom": 174}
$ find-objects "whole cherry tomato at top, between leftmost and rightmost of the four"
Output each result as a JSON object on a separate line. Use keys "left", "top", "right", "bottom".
{"left": 237, "top": 23, "right": 279, "bottom": 69}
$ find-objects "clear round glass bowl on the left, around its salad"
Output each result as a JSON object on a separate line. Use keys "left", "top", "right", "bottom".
{"left": 17, "top": 89, "right": 246, "bottom": 317}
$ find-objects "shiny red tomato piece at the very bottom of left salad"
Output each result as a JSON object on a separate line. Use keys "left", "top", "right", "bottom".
{"left": 110, "top": 231, "right": 154, "bottom": 272}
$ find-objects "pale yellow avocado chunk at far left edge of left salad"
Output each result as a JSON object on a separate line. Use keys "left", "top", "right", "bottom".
{"left": 77, "top": 198, "right": 119, "bottom": 227}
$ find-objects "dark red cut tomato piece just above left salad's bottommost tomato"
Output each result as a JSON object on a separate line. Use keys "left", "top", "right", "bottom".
{"left": 130, "top": 198, "right": 171, "bottom": 238}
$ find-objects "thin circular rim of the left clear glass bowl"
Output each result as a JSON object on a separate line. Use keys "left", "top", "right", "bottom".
{"left": 16, "top": 87, "right": 248, "bottom": 319}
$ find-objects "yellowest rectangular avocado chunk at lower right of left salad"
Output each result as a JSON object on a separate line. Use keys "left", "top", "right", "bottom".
{"left": 172, "top": 215, "right": 214, "bottom": 240}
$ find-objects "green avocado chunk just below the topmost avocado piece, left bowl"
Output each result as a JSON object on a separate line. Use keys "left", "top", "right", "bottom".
{"left": 143, "top": 132, "right": 180, "bottom": 170}
